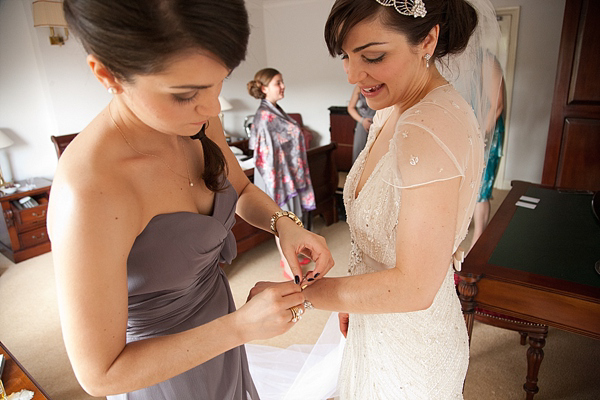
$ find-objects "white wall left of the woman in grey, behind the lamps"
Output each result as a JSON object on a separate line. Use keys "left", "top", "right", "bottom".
{"left": 0, "top": 0, "right": 110, "bottom": 180}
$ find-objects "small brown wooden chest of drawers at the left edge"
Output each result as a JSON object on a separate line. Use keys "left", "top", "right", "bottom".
{"left": 0, "top": 178, "right": 52, "bottom": 263}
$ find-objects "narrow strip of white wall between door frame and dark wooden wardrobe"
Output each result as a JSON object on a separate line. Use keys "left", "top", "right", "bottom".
{"left": 491, "top": 0, "right": 565, "bottom": 183}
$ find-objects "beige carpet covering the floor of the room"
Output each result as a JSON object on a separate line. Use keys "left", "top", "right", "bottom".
{"left": 0, "top": 192, "right": 600, "bottom": 400}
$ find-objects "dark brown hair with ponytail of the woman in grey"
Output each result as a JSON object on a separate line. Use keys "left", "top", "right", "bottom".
{"left": 63, "top": 0, "right": 250, "bottom": 191}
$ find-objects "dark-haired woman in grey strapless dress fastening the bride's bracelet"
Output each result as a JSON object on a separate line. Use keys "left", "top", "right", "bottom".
{"left": 48, "top": 0, "right": 333, "bottom": 400}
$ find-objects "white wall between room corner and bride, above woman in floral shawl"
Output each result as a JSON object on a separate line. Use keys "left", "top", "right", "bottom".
{"left": 264, "top": 0, "right": 342, "bottom": 145}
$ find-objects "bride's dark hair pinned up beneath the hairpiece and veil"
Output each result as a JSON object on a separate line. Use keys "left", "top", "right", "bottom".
{"left": 325, "top": 0, "right": 477, "bottom": 60}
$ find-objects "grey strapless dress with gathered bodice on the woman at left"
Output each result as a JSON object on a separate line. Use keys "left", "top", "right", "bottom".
{"left": 107, "top": 185, "right": 259, "bottom": 400}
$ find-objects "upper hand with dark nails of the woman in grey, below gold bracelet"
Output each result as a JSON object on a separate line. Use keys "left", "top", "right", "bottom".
{"left": 277, "top": 218, "right": 334, "bottom": 283}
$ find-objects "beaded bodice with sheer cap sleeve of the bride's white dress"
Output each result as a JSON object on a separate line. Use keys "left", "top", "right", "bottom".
{"left": 344, "top": 85, "right": 483, "bottom": 274}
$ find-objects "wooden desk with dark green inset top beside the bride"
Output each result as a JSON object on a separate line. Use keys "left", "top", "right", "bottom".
{"left": 458, "top": 181, "right": 600, "bottom": 399}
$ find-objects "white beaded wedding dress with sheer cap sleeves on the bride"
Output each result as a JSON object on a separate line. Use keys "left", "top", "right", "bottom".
{"left": 339, "top": 85, "right": 484, "bottom": 400}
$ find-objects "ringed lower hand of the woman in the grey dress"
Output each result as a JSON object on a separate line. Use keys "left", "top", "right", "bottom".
{"left": 234, "top": 282, "right": 304, "bottom": 342}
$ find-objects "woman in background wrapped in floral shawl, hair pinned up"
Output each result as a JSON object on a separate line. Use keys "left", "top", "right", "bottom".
{"left": 247, "top": 68, "right": 315, "bottom": 279}
